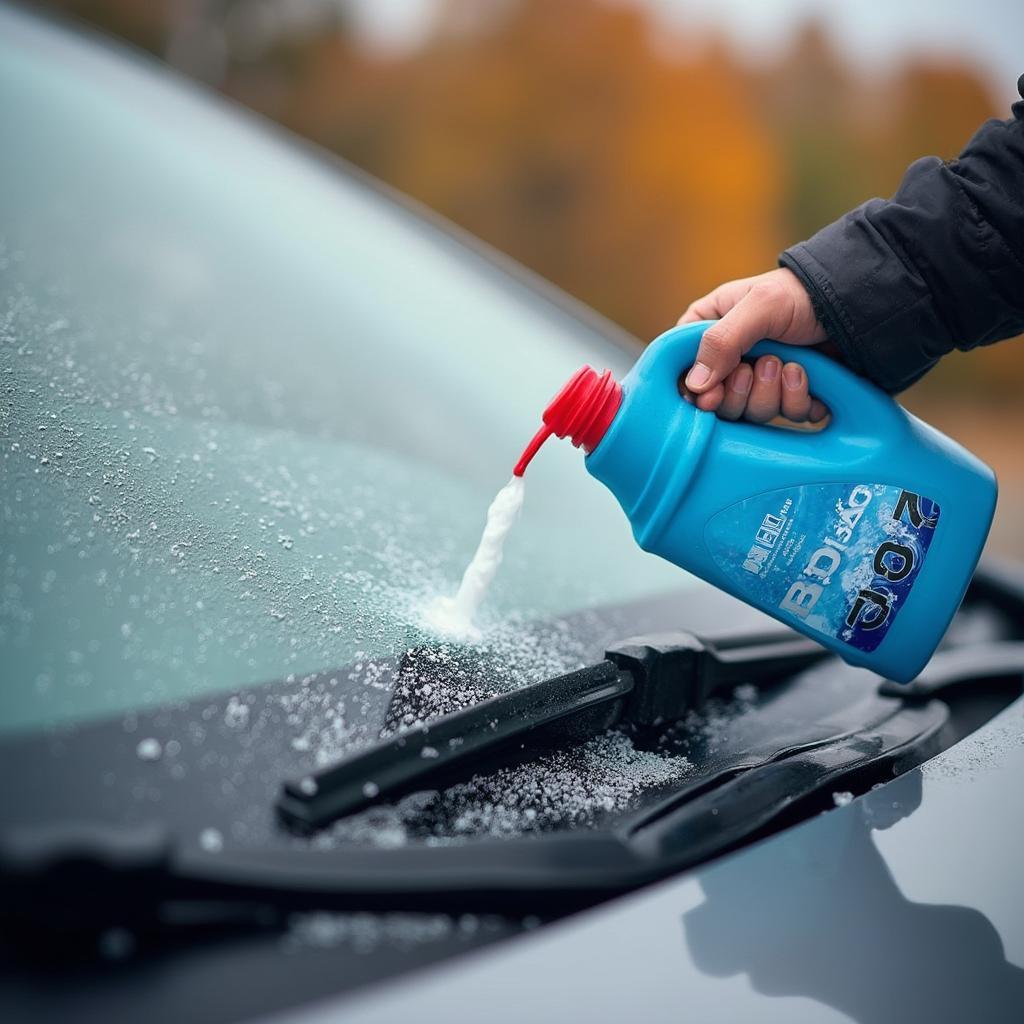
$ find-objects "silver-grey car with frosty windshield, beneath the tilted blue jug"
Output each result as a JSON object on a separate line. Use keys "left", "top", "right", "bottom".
{"left": 0, "top": 8, "right": 1024, "bottom": 1021}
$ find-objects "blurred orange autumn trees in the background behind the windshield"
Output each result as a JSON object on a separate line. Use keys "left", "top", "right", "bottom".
{"left": 37, "top": 0, "right": 1024, "bottom": 552}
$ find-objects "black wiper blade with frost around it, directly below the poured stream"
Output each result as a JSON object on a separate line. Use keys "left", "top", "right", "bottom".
{"left": 278, "top": 632, "right": 827, "bottom": 827}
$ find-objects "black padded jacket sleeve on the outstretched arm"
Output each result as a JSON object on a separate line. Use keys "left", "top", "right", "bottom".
{"left": 779, "top": 75, "right": 1024, "bottom": 391}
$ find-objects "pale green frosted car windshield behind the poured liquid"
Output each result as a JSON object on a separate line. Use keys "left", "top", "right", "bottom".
{"left": 0, "top": 11, "right": 686, "bottom": 729}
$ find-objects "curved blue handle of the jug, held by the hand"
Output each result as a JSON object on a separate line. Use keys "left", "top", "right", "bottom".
{"left": 630, "top": 321, "right": 898, "bottom": 437}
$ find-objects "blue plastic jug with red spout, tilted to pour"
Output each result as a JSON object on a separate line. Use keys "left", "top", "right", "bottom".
{"left": 515, "top": 322, "right": 996, "bottom": 682}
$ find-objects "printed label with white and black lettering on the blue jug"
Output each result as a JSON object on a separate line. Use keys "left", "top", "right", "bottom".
{"left": 705, "top": 483, "right": 939, "bottom": 651}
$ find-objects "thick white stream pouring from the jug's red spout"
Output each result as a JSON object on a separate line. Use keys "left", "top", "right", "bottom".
{"left": 424, "top": 476, "right": 525, "bottom": 640}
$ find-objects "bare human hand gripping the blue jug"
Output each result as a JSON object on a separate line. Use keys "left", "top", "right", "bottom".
{"left": 679, "top": 268, "right": 828, "bottom": 423}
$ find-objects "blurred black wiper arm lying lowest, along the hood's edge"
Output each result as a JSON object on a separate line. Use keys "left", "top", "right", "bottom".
{"left": 8, "top": 642, "right": 1024, "bottom": 963}
